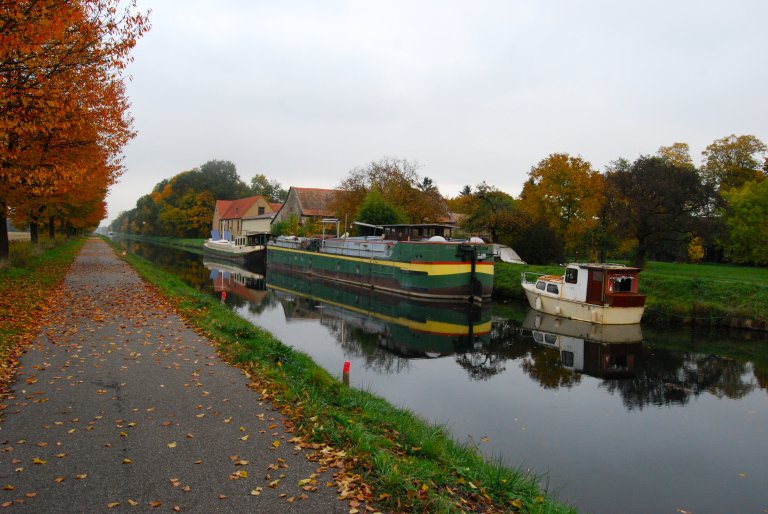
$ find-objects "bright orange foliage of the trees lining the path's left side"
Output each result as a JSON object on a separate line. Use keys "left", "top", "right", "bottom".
{"left": 0, "top": 0, "right": 149, "bottom": 258}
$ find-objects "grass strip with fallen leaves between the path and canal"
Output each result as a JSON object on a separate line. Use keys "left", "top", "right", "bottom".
{"left": 112, "top": 238, "right": 573, "bottom": 513}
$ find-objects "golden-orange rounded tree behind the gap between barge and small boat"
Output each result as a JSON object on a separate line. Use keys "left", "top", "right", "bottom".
{"left": 520, "top": 153, "right": 605, "bottom": 255}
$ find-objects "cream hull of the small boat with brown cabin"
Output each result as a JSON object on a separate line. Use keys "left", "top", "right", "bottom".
{"left": 522, "top": 283, "right": 645, "bottom": 325}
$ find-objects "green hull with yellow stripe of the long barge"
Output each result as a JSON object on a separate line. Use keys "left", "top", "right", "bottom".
{"left": 267, "top": 239, "right": 493, "bottom": 301}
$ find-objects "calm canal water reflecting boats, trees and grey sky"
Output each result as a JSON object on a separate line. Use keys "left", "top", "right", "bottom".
{"left": 118, "top": 237, "right": 768, "bottom": 514}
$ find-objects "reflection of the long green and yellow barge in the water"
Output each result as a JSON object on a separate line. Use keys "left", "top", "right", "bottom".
{"left": 267, "top": 269, "right": 491, "bottom": 358}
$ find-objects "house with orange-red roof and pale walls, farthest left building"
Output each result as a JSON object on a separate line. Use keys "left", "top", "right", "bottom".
{"left": 212, "top": 195, "right": 276, "bottom": 239}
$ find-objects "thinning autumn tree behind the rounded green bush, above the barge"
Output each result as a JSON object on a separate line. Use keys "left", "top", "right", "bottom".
{"left": 332, "top": 158, "right": 448, "bottom": 227}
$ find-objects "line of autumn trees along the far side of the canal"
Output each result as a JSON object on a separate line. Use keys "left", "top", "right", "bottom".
{"left": 111, "top": 135, "right": 768, "bottom": 265}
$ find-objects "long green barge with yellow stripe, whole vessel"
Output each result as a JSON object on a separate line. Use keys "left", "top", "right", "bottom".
{"left": 267, "top": 224, "right": 494, "bottom": 302}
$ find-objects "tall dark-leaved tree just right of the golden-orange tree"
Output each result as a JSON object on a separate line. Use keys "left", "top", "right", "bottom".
{"left": 606, "top": 156, "right": 707, "bottom": 266}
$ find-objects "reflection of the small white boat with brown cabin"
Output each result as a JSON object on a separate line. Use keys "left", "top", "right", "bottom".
{"left": 522, "top": 309, "right": 643, "bottom": 378}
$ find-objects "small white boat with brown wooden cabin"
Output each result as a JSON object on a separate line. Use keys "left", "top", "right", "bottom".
{"left": 521, "top": 263, "right": 645, "bottom": 325}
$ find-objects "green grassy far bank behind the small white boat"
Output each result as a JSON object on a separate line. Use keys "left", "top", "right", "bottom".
{"left": 493, "top": 262, "right": 768, "bottom": 331}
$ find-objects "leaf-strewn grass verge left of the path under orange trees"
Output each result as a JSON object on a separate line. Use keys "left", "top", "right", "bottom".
{"left": 0, "top": 238, "right": 85, "bottom": 392}
